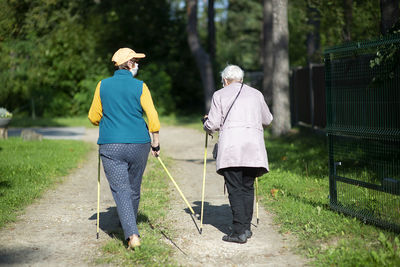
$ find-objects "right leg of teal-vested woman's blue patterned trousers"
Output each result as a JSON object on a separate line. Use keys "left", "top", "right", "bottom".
{"left": 127, "top": 143, "right": 150, "bottom": 221}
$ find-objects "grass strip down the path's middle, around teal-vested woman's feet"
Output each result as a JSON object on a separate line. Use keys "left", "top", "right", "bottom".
{"left": 96, "top": 157, "right": 176, "bottom": 266}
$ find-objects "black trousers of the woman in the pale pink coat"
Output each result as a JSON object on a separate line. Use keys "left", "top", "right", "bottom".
{"left": 222, "top": 167, "right": 257, "bottom": 235}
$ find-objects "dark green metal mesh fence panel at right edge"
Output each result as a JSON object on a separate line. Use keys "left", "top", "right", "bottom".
{"left": 324, "top": 35, "right": 400, "bottom": 232}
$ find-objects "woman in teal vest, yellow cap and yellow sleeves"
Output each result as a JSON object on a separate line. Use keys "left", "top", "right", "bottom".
{"left": 88, "top": 48, "right": 160, "bottom": 251}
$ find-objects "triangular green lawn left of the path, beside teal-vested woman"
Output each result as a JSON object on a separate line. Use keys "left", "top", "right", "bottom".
{"left": 0, "top": 138, "right": 91, "bottom": 227}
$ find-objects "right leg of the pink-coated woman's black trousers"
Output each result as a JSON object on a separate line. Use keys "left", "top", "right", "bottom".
{"left": 243, "top": 168, "right": 255, "bottom": 230}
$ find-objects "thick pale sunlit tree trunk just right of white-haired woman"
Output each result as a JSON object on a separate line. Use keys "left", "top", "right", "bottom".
{"left": 272, "top": 0, "right": 291, "bottom": 136}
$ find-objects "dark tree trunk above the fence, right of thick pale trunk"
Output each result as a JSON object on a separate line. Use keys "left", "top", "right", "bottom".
{"left": 306, "top": 5, "right": 321, "bottom": 63}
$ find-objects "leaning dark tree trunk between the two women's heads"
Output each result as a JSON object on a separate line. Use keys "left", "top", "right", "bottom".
{"left": 186, "top": 0, "right": 215, "bottom": 112}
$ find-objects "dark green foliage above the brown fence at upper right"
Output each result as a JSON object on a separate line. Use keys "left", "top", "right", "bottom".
{"left": 288, "top": 0, "right": 380, "bottom": 66}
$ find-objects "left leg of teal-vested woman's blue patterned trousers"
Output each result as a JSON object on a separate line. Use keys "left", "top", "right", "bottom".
{"left": 100, "top": 144, "right": 139, "bottom": 239}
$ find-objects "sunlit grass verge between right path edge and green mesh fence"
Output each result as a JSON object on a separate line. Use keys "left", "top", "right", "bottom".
{"left": 260, "top": 129, "right": 400, "bottom": 266}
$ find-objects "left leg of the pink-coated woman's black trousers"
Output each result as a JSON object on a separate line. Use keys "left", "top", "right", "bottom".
{"left": 223, "top": 168, "right": 246, "bottom": 235}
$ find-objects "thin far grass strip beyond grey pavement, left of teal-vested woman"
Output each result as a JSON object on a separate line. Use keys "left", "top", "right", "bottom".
{"left": 9, "top": 116, "right": 96, "bottom": 128}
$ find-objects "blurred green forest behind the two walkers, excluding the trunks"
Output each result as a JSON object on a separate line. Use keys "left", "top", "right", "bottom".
{"left": 0, "top": 0, "right": 398, "bottom": 121}
